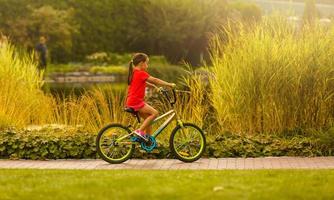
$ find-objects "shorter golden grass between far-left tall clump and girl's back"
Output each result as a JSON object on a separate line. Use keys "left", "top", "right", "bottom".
{"left": 45, "top": 86, "right": 133, "bottom": 133}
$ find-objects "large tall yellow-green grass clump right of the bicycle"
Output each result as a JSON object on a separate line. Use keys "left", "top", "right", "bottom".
{"left": 210, "top": 18, "right": 334, "bottom": 133}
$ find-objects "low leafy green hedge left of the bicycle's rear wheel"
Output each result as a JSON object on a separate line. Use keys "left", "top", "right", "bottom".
{"left": 0, "top": 127, "right": 96, "bottom": 159}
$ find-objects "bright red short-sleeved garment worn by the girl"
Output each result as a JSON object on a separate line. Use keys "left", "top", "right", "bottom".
{"left": 126, "top": 69, "right": 150, "bottom": 107}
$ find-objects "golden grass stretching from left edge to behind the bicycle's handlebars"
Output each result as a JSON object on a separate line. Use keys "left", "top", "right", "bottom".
{"left": 0, "top": 43, "right": 206, "bottom": 133}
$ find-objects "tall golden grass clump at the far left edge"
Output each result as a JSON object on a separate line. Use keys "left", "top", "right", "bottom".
{"left": 0, "top": 41, "right": 46, "bottom": 128}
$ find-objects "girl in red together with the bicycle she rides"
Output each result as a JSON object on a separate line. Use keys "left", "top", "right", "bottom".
{"left": 96, "top": 53, "right": 206, "bottom": 164}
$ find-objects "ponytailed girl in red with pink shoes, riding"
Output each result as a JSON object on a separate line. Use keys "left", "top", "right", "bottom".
{"left": 126, "top": 53, "right": 175, "bottom": 140}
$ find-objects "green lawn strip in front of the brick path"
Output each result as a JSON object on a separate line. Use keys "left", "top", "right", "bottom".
{"left": 0, "top": 169, "right": 334, "bottom": 200}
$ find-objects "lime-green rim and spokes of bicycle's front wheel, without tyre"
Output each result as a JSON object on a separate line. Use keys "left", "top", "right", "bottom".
{"left": 173, "top": 126, "right": 205, "bottom": 160}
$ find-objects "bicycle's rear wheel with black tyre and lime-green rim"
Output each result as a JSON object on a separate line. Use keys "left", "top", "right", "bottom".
{"left": 96, "top": 124, "right": 135, "bottom": 164}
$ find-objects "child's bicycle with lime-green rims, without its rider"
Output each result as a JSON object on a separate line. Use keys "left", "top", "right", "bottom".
{"left": 96, "top": 88, "right": 206, "bottom": 164}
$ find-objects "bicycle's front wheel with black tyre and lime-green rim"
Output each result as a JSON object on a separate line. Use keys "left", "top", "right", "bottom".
{"left": 169, "top": 123, "right": 206, "bottom": 162}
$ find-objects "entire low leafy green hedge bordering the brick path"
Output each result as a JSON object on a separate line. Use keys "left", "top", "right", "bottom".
{"left": 0, "top": 126, "right": 334, "bottom": 159}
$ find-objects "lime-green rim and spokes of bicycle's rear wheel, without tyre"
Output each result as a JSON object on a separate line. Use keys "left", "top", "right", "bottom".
{"left": 99, "top": 127, "right": 132, "bottom": 161}
